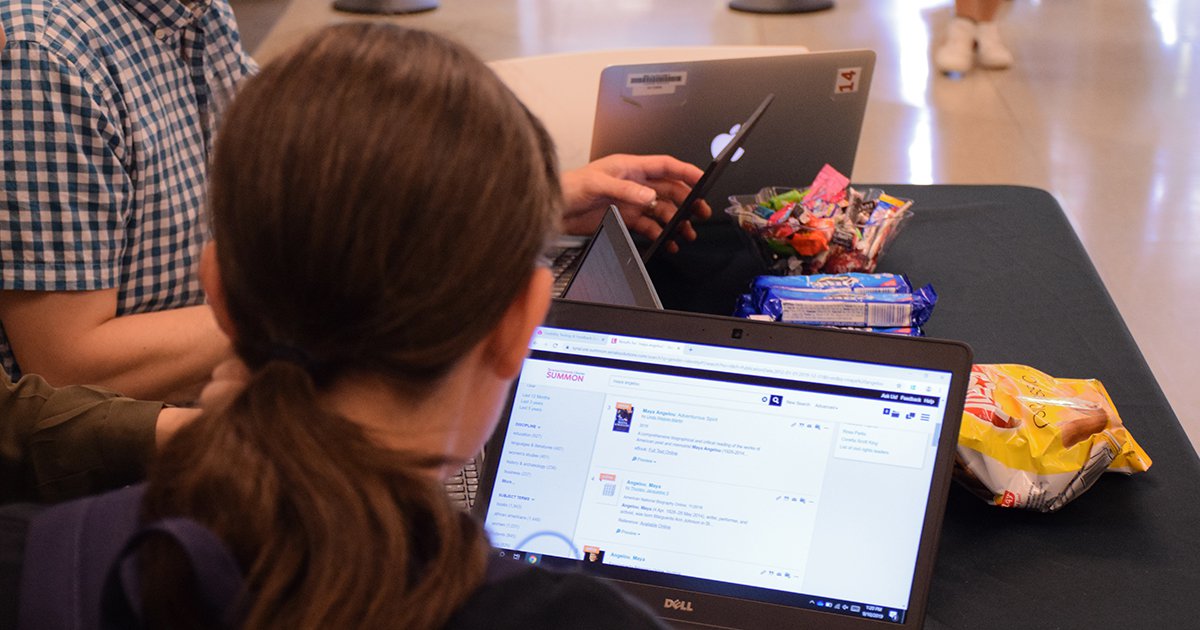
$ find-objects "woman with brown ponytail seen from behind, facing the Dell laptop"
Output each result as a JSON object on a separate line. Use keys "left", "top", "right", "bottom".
{"left": 0, "top": 24, "right": 658, "bottom": 629}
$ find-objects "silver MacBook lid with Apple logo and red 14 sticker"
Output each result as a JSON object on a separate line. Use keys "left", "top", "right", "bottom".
{"left": 592, "top": 50, "right": 875, "bottom": 208}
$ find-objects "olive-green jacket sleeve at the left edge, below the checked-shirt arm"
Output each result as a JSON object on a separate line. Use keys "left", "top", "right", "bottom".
{"left": 0, "top": 370, "right": 162, "bottom": 504}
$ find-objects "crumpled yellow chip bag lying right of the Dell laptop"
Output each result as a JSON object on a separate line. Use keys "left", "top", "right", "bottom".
{"left": 954, "top": 365, "right": 1151, "bottom": 512}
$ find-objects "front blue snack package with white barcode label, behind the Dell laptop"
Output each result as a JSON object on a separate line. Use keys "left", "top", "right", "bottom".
{"left": 757, "top": 284, "right": 937, "bottom": 328}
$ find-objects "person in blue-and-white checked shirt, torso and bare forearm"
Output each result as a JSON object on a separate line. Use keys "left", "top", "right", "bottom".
{"left": 0, "top": 0, "right": 256, "bottom": 400}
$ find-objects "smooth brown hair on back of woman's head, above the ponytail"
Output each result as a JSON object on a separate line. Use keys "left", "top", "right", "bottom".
{"left": 210, "top": 24, "right": 558, "bottom": 385}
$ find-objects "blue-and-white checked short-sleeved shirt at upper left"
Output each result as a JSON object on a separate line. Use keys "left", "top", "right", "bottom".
{"left": 0, "top": 0, "right": 257, "bottom": 379}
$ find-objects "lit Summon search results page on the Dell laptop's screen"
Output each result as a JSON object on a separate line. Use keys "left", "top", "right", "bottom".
{"left": 486, "top": 328, "right": 949, "bottom": 620}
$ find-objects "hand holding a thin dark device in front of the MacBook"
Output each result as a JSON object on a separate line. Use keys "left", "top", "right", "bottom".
{"left": 563, "top": 154, "right": 713, "bottom": 252}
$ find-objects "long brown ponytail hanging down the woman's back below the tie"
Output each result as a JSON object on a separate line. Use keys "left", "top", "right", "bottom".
{"left": 145, "top": 361, "right": 487, "bottom": 628}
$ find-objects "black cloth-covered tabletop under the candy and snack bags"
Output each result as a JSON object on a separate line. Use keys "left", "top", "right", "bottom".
{"left": 650, "top": 185, "right": 1200, "bottom": 629}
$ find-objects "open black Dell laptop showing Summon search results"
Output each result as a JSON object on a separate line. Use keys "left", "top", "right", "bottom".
{"left": 474, "top": 301, "right": 971, "bottom": 630}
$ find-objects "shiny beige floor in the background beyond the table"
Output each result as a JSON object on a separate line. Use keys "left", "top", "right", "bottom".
{"left": 234, "top": 0, "right": 1200, "bottom": 446}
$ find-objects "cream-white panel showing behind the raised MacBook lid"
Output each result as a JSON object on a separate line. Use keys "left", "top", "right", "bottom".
{"left": 488, "top": 46, "right": 808, "bottom": 169}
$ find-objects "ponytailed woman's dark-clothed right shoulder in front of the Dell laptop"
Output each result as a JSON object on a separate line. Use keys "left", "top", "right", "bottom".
{"left": 446, "top": 559, "right": 666, "bottom": 630}
